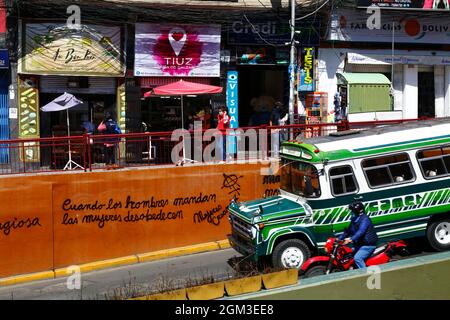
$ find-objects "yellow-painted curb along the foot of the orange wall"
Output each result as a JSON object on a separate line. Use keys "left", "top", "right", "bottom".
{"left": 0, "top": 240, "right": 230, "bottom": 287}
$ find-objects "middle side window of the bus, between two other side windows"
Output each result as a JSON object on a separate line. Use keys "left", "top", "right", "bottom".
{"left": 361, "top": 153, "right": 415, "bottom": 188}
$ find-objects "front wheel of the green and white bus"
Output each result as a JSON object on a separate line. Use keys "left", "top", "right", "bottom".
{"left": 272, "top": 239, "right": 311, "bottom": 269}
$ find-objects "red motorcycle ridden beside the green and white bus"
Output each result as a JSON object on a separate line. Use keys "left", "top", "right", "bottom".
{"left": 300, "top": 238, "right": 408, "bottom": 278}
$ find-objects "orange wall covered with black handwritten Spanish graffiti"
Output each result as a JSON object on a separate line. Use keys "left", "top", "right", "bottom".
{"left": 0, "top": 164, "right": 278, "bottom": 277}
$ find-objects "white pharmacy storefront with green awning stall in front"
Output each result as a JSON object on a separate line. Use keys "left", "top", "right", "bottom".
{"left": 318, "top": 10, "right": 450, "bottom": 121}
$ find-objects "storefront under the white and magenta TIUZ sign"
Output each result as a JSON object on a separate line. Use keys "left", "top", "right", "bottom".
{"left": 134, "top": 23, "right": 221, "bottom": 131}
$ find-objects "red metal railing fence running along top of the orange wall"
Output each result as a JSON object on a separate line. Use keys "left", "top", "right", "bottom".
{"left": 0, "top": 119, "right": 426, "bottom": 175}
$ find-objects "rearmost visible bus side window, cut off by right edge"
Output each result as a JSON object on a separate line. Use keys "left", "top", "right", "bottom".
{"left": 416, "top": 147, "right": 450, "bottom": 179}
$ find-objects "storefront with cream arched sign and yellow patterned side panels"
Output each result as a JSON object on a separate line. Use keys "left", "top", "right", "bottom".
{"left": 18, "top": 22, "right": 126, "bottom": 165}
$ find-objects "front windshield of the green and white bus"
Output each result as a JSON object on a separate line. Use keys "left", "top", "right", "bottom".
{"left": 281, "top": 159, "right": 320, "bottom": 198}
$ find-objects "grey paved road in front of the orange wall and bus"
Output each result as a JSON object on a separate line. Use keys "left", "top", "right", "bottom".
{"left": 0, "top": 238, "right": 433, "bottom": 300}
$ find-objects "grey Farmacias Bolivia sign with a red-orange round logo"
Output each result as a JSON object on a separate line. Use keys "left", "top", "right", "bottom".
{"left": 327, "top": 10, "right": 450, "bottom": 44}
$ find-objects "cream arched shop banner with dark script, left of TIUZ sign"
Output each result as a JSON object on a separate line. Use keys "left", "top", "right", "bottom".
{"left": 19, "top": 24, "right": 124, "bottom": 77}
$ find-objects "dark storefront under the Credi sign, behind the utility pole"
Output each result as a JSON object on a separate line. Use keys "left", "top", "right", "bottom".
{"left": 226, "top": 16, "right": 320, "bottom": 126}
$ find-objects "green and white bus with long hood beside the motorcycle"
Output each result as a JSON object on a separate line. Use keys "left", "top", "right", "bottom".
{"left": 228, "top": 120, "right": 450, "bottom": 268}
